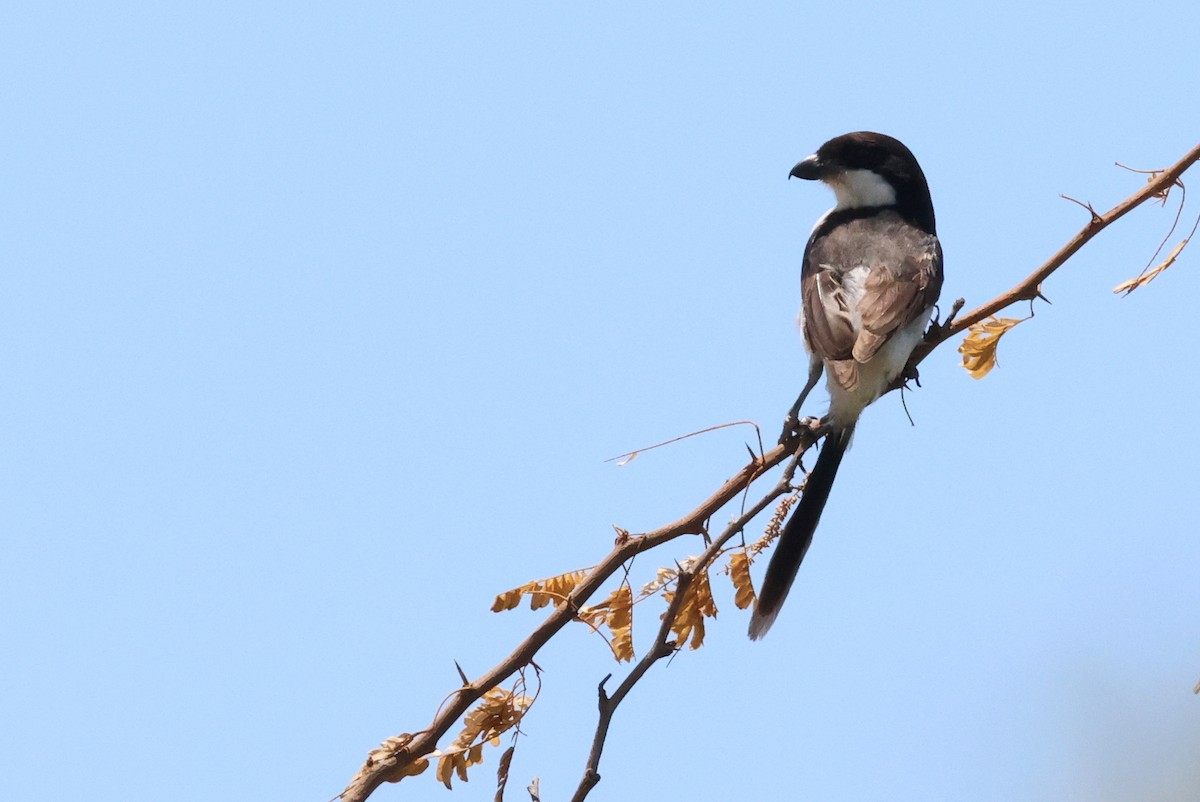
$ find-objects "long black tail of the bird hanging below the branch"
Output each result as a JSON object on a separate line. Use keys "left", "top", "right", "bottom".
{"left": 750, "top": 425, "right": 854, "bottom": 640}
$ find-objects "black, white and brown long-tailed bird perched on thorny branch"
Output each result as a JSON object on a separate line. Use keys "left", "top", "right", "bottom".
{"left": 749, "top": 131, "right": 943, "bottom": 640}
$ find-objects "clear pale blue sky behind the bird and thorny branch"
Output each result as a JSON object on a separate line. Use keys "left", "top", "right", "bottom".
{"left": 0, "top": 1, "right": 1200, "bottom": 801}
